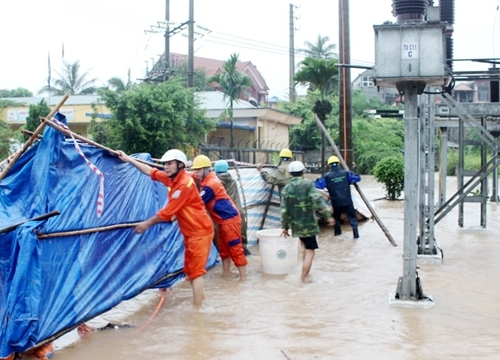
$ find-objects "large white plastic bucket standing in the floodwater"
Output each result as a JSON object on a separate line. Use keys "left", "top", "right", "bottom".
{"left": 257, "top": 229, "right": 299, "bottom": 275}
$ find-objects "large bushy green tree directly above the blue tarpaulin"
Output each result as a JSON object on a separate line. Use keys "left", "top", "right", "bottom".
{"left": 94, "top": 79, "right": 215, "bottom": 157}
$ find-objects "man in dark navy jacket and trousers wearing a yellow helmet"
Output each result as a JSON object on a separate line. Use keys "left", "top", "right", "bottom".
{"left": 323, "top": 156, "right": 361, "bottom": 239}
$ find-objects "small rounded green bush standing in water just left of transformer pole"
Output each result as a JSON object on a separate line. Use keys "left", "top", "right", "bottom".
{"left": 373, "top": 155, "right": 405, "bottom": 200}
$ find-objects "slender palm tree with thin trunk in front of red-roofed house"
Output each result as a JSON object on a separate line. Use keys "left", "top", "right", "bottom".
{"left": 209, "top": 54, "right": 251, "bottom": 148}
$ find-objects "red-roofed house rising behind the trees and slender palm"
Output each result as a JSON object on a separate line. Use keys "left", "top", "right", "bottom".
{"left": 170, "top": 53, "right": 269, "bottom": 105}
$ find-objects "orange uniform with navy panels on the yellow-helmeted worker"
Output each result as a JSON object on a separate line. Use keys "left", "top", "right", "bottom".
{"left": 200, "top": 172, "right": 247, "bottom": 266}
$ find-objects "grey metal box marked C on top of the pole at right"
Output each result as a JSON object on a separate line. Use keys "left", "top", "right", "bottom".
{"left": 373, "top": 22, "right": 450, "bottom": 87}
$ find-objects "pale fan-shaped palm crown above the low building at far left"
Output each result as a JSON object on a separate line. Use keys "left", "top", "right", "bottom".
{"left": 38, "top": 60, "right": 96, "bottom": 95}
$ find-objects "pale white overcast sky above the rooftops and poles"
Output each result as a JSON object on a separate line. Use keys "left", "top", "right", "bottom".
{"left": 0, "top": 0, "right": 500, "bottom": 98}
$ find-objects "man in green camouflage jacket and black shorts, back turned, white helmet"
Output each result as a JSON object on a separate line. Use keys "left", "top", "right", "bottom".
{"left": 281, "top": 161, "right": 335, "bottom": 282}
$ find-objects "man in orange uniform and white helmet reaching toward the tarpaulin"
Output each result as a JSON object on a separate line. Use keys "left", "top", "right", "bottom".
{"left": 118, "top": 149, "right": 214, "bottom": 308}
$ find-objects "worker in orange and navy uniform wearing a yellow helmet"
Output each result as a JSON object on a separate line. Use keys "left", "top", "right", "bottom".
{"left": 191, "top": 155, "right": 247, "bottom": 280}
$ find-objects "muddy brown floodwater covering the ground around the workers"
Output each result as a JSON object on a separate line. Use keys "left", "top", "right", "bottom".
{"left": 47, "top": 176, "right": 500, "bottom": 360}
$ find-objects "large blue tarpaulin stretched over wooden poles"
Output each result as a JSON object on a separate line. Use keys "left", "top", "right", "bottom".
{"left": 0, "top": 114, "right": 217, "bottom": 358}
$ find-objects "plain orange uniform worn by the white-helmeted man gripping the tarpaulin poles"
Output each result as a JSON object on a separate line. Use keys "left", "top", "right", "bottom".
{"left": 150, "top": 168, "right": 214, "bottom": 280}
